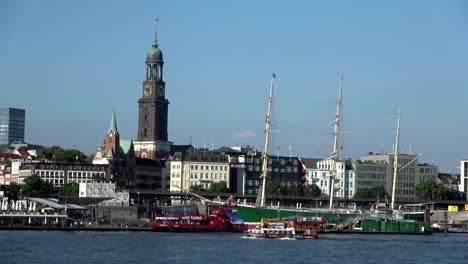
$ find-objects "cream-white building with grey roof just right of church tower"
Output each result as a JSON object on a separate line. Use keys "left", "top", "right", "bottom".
{"left": 169, "top": 152, "right": 229, "bottom": 192}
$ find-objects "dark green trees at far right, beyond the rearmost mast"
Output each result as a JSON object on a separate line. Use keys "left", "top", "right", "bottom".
{"left": 415, "top": 179, "right": 462, "bottom": 201}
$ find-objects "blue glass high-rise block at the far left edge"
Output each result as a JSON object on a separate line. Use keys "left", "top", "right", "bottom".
{"left": 0, "top": 107, "right": 26, "bottom": 145}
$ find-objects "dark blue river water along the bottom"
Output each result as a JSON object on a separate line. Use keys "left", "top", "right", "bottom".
{"left": 0, "top": 231, "right": 468, "bottom": 264}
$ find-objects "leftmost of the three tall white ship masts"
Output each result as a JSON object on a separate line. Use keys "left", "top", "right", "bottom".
{"left": 255, "top": 73, "right": 276, "bottom": 207}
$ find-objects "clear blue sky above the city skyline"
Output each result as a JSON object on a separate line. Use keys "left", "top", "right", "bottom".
{"left": 0, "top": 0, "right": 468, "bottom": 172}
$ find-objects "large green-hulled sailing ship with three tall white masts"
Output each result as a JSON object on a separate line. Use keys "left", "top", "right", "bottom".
{"left": 230, "top": 76, "right": 429, "bottom": 233}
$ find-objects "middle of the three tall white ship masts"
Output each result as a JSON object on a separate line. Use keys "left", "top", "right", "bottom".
{"left": 328, "top": 76, "right": 343, "bottom": 210}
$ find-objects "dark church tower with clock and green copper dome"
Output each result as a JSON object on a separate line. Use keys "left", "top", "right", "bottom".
{"left": 134, "top": 20, "right": 171, "bottom": 159}
